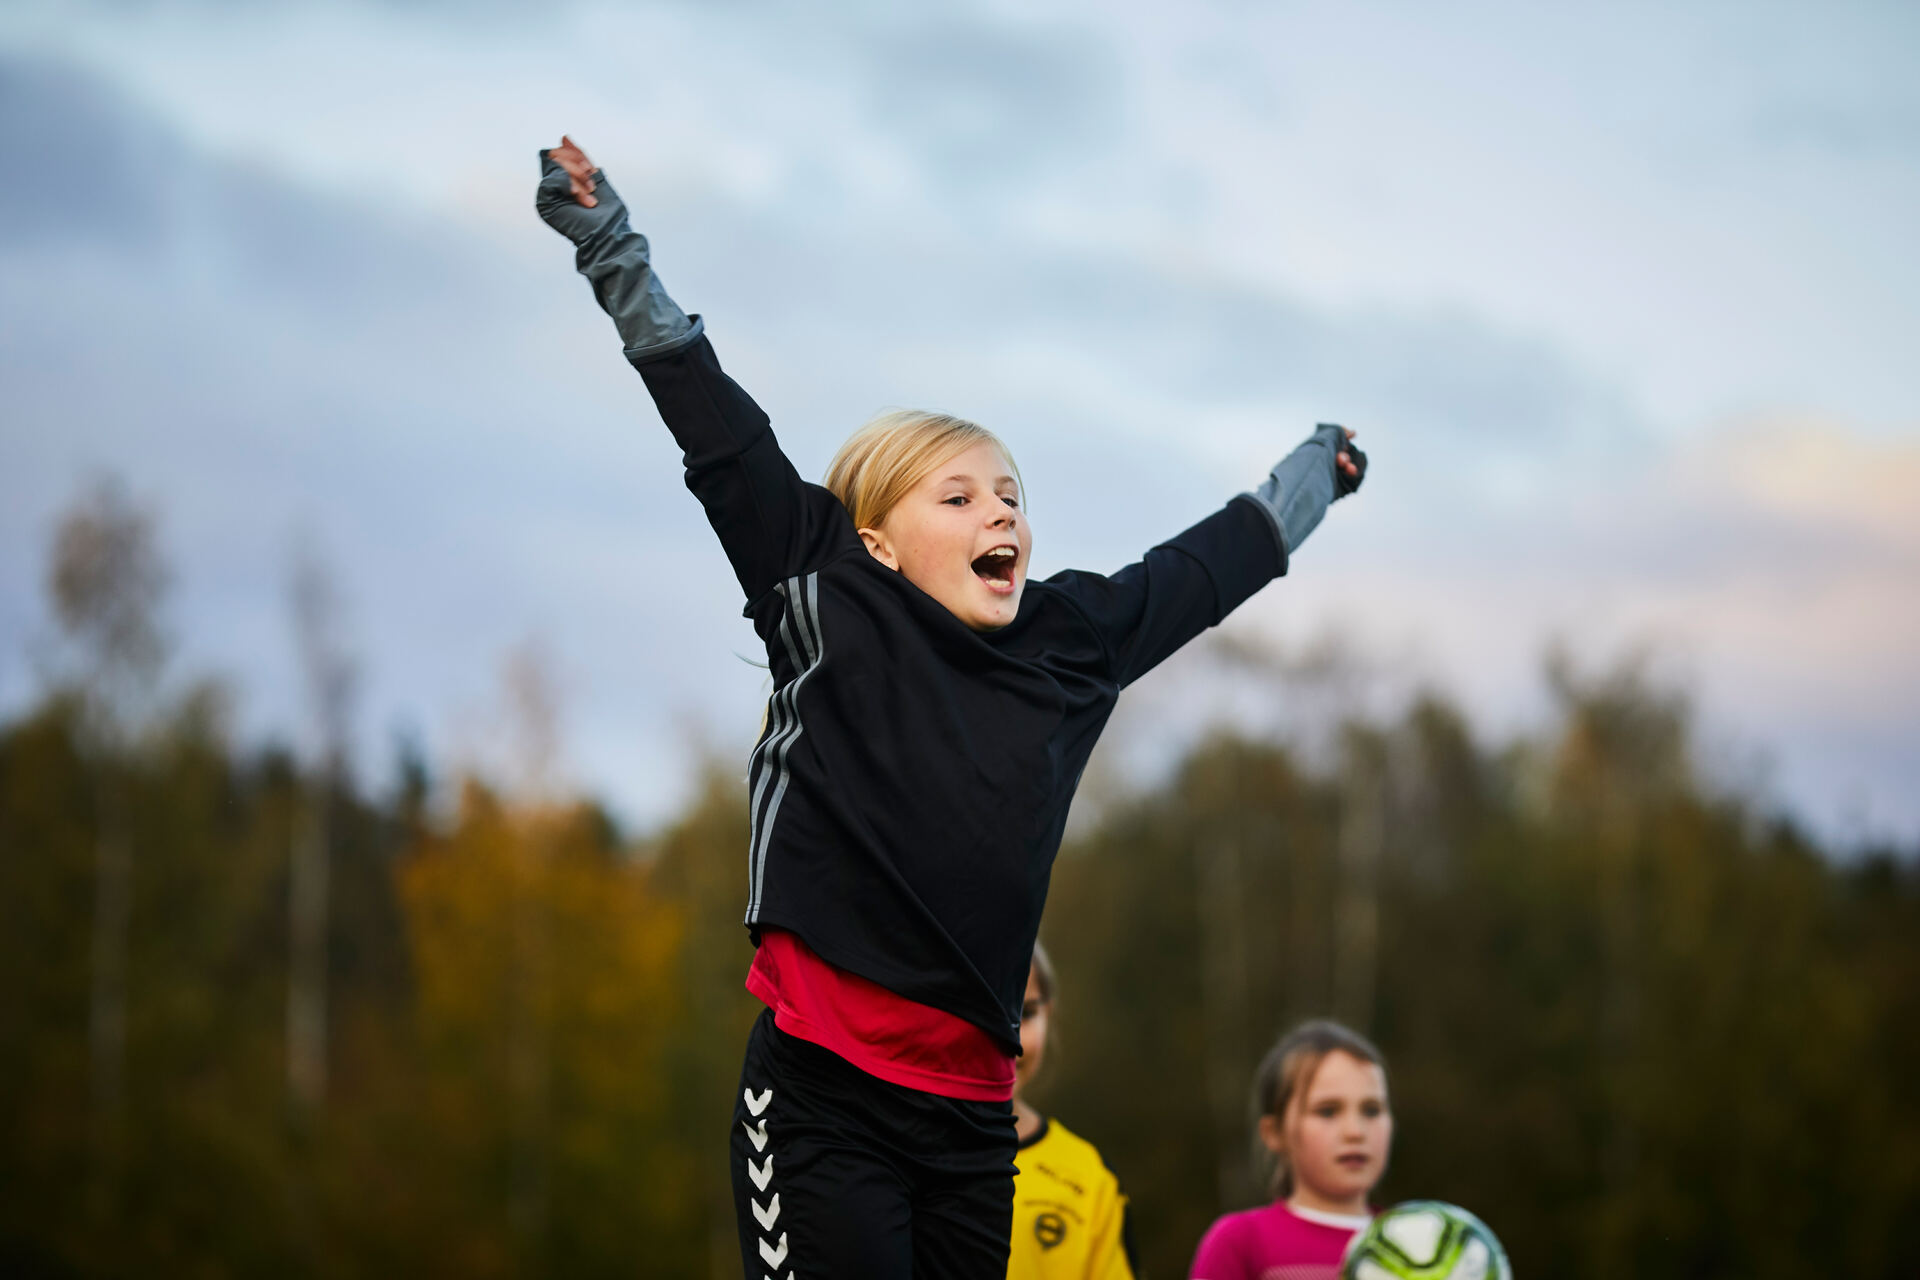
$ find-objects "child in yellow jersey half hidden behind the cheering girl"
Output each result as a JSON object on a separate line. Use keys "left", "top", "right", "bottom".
{"left": 1006, "top": 942, "right": 1139, "bottom": 1280}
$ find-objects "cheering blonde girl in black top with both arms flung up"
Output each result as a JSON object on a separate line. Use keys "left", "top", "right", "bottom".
{"left": 536, "top": 138, "right": 1365, "bottom": 1280}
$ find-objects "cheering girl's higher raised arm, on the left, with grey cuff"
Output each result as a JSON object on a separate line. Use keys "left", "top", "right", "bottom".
{"left": 534, "top": 144, "right": 860, "bottom": 604}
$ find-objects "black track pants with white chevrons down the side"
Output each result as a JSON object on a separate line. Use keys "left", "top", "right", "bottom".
{"left": 728, "top": 1011, "right": 1016, "bottom": 1280}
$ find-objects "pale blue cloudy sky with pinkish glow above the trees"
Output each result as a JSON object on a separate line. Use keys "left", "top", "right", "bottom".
{"left": 0, "top": 0, "right": 1920, "bottom": 846}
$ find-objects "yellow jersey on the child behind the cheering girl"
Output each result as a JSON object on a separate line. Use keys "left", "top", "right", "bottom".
{"left": 1006, "top": 1119, "right": 1139, "bottom": 1280}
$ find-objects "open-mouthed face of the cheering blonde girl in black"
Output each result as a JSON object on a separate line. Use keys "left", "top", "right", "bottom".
{"left": 860, "top": 441, "right": 1033, "bottom": 631}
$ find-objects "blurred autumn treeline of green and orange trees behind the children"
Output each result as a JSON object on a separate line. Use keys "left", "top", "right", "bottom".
{"left": 0, "top": 489, "right": 1920, "bottom": 1280}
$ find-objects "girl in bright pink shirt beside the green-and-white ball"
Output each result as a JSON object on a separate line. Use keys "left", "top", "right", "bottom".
{"left": 1188, "top": 1021, "right": 1394, "bottom": 1280}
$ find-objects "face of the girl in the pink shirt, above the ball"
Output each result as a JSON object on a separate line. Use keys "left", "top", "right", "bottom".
{"left": 1260, "top": 1050, "right": 1394, "bottom": 1213}
